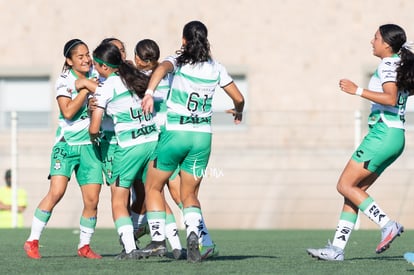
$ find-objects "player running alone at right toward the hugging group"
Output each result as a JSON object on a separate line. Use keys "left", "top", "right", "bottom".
{"left": 307, "top": 24, "right": 414, "bottom": 261}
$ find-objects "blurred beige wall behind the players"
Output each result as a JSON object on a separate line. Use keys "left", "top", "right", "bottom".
{"left": 0, "top": 0, "right": 414, "bottom": 229}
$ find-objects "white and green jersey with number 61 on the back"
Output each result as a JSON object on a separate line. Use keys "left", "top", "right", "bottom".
{"left": 166, "top": 56, "right": 233, "bottom": 133}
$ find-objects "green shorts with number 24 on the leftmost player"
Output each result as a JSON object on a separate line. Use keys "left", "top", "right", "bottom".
{"left": 50, "top": 141, "right": 103, "bottom": 185}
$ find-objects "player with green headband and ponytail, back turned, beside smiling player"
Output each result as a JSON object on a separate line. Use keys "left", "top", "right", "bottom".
{"left": 77, "top": 43, "right": 158, "bottom": 259}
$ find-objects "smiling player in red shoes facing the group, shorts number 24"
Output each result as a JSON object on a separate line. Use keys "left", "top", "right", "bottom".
{"left": 24, "top": 39, "right": 103, "bottom": 259}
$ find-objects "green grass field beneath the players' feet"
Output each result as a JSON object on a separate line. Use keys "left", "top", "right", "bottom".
{"left": 4, "top": 228, "right": 414, "bottom": 275}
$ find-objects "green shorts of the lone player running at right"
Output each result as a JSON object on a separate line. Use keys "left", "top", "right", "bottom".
{"left": 352, "top": 121, "right": 405, "bottom": 175}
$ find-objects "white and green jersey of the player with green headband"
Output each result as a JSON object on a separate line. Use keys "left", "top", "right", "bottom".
{"left": 95, "top": 74, "right": 158, "bottom": 147}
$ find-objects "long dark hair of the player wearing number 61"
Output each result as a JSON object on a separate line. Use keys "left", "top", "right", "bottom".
{"left": 177, "top": 21, "right": 211, "bottom": 66}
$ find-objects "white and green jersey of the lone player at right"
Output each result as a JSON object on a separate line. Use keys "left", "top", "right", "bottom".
{"left": 368, "top": 55, "right": 409, "bottom": 129}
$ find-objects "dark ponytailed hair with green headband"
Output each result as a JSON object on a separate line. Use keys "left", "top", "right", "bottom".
{"left": 93, "top": 42, "right": 149, "bottom": 98}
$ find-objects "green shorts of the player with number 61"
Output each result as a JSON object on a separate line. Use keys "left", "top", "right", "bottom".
{"left": 151, "top": 130, "right": 211, "bottom": 178}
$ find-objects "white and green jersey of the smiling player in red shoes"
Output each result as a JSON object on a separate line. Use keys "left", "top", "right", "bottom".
{"left": 55, "top": 70, "right": 97, "bottom": 145}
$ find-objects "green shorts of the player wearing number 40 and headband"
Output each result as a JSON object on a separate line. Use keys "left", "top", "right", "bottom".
{"left": 109, "top": 141, "right": 157, "bottom": 188}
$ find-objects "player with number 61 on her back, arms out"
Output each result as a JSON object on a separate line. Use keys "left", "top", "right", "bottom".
{"left": 139, "top": 21, "right": 244, "bottom": 262}
